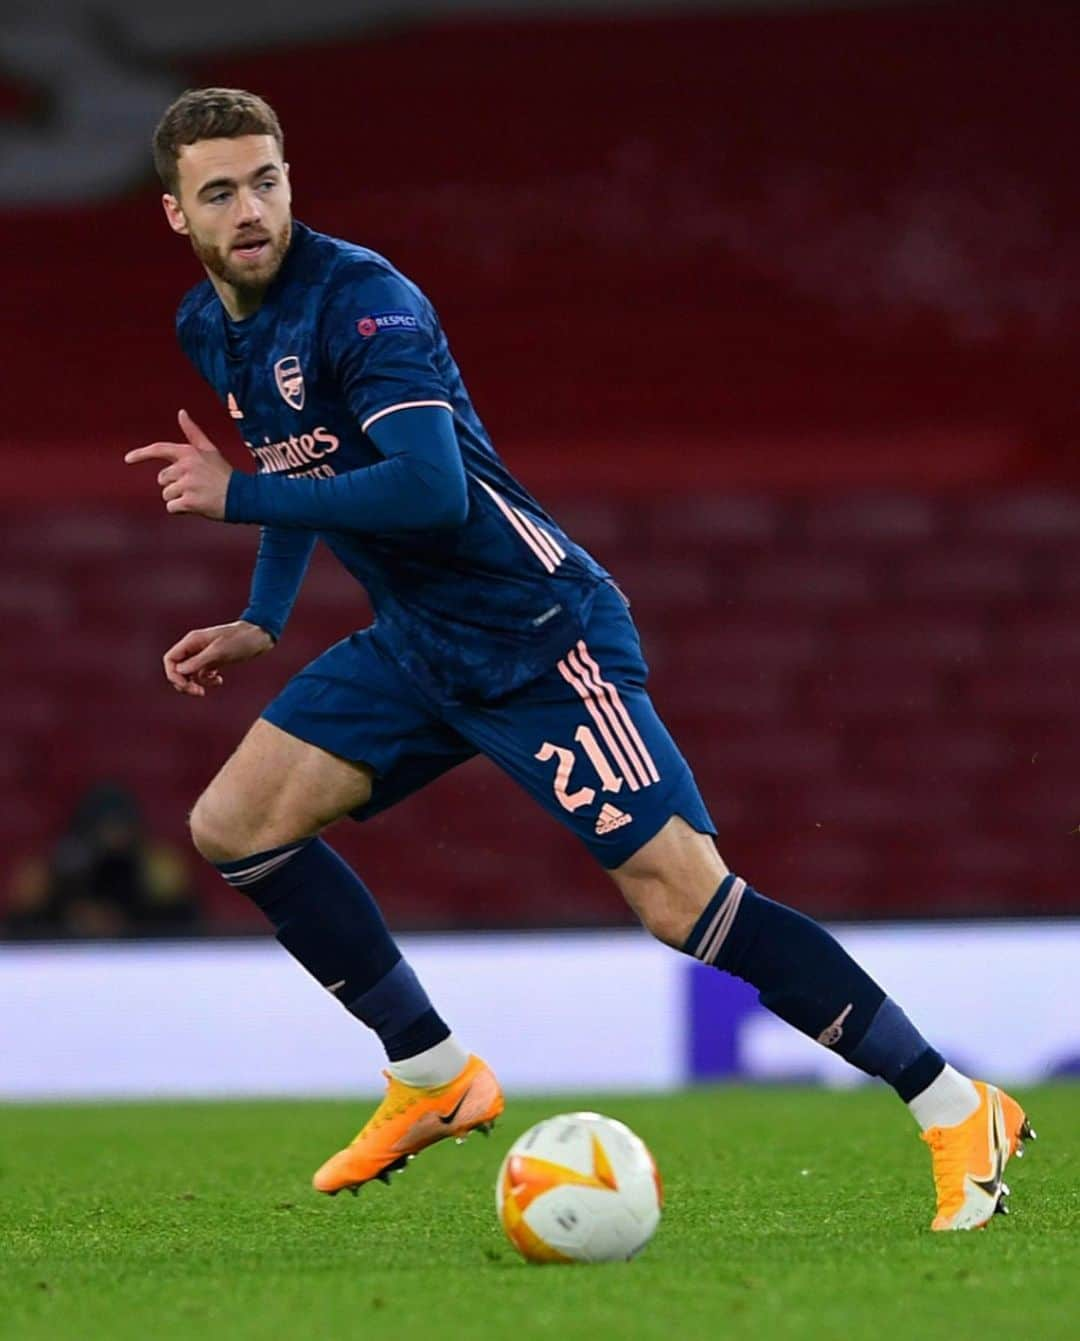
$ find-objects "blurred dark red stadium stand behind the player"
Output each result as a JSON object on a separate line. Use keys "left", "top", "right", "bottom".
{"left": 0, "top": 4, "right": 1080, "bottom": 927}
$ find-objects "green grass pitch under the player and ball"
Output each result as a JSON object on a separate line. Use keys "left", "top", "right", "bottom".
{"left": 0, "top": 1085, "right": 1080, "bottom": 1341}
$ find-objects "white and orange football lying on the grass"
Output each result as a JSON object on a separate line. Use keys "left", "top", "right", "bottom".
{"left": 495, "top": 1113, "right": 664, "bottom": 1262}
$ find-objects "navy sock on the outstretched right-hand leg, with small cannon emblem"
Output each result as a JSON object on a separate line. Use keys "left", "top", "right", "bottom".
{"left": 683, "top": 876, "right": 944, "bottom": 1102}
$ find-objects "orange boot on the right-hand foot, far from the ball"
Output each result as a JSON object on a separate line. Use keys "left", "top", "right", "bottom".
{"left": 922, "top": 1081, "right": 1036, "bottom": 1230}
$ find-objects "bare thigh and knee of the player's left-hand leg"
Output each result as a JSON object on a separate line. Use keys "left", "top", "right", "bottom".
{"left": 191, "top": 717, "right": 373, "bottom": 862}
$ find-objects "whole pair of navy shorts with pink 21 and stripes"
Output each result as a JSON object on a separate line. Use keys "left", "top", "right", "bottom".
{"left": 263, "top": 586, "right": 716, "bottom": 869}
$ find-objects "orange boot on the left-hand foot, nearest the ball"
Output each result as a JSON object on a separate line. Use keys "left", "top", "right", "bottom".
{"left": 311, "top": 1055, "right": 503, "bottom": 1196}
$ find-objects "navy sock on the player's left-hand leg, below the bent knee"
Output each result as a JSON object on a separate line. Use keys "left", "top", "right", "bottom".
{"left": 217, "top": 838, "right": 449, "bottom": 1062}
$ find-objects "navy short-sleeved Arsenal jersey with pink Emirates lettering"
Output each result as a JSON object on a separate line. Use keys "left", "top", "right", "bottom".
{"left": 177, "top": 223, "right": 608, "bottom": 700}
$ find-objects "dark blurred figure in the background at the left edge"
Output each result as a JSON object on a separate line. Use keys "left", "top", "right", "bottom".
{"left": 3, "top": 783, "right": 199, "bottom": 939}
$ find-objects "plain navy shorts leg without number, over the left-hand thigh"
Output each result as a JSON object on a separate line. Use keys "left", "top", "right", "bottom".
{"left": 262, "top": 630, "right": 476, "bottom": 819}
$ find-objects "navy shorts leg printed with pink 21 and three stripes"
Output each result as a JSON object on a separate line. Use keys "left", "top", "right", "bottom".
{"left": 452, "top": 587, "right": 715, "bottom": 869}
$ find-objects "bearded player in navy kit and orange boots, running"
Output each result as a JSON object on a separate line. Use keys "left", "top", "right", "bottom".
{"left": 126, "top": 89, "right": 1032, "bottom": 1230}
